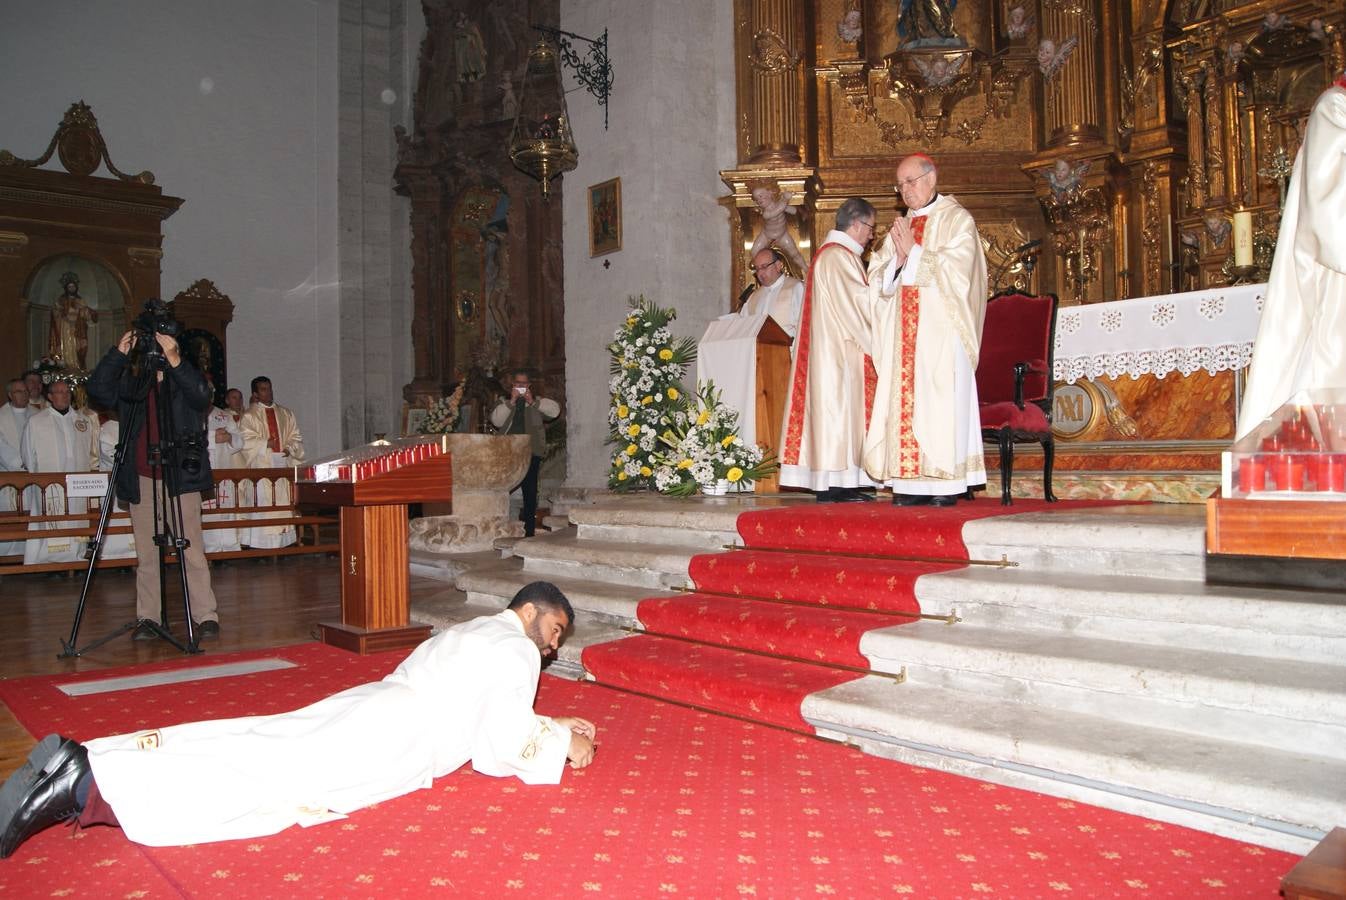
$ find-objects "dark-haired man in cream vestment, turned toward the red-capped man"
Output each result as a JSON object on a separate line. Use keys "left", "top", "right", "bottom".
{"left": 778, "top": 198, "right": 892, "bottom": 503}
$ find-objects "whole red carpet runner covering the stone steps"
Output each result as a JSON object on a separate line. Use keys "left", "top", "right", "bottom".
{"left": 581, "top": 499, "right": 1125, "bottom": 733}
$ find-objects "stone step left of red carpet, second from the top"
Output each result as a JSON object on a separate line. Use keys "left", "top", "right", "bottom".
{"left": 513, "top": 531, "right": 697, "bottom": 591}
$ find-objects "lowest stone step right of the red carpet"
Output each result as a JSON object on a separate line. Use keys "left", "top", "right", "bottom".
{"left": 804, "top": 677, "right": 1346, "bottom": 853}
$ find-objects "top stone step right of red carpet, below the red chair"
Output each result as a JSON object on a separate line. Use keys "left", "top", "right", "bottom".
{"left": 962, "top": 503, "right": 1206, "bottom": 581}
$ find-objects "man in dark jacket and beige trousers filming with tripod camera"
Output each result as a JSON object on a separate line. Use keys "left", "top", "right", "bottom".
{"left": 87, "top": 328, "right": 219, "bottom": 640}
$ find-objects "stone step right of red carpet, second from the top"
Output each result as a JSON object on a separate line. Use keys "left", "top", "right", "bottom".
{"left": 917, "top": 566, "right": 1346, "bottom": 665}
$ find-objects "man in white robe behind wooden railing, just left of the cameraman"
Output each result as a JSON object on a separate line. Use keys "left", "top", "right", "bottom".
{"left": 20, "top": 381, "right": 98, "bottom": 565}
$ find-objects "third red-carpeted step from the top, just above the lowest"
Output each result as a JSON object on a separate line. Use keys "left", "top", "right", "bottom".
{"left": 635, "top": 593, "right": 913, "bottom": 669}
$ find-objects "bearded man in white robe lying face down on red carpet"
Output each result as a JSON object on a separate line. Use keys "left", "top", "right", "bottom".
{"left": 0, "top": 581, "right": 595, "bottom": 856}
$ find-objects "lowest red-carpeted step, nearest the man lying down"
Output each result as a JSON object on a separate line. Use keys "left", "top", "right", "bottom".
{"left": 580, "top": 635, "right": 859, "bottom": 735}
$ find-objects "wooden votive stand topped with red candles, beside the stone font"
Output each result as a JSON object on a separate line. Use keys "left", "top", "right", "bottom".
{"left": 295, "top": 444, "right": 452, "bottom": 655}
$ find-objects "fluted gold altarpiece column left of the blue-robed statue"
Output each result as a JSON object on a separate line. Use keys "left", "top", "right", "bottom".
{"left": 735, "top": 0, "right": 805, "bottom": 165}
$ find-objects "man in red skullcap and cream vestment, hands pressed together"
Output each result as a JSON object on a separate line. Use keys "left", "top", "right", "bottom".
{"left": 864, "top": 153, "right": 987, "bottom": 506}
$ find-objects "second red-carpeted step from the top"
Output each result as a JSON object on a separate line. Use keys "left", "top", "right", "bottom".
{"left": 689, "top": 550, "right": 962, "bottom": 612}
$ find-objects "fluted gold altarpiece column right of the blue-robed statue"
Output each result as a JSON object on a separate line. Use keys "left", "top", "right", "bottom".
{"left": 1042, "top": 0, "right": 1102, "bottom": 147}
